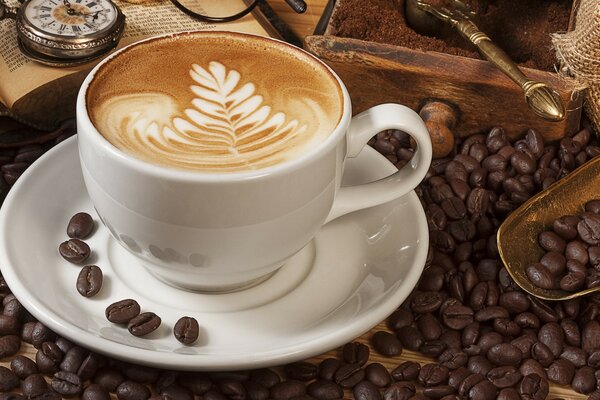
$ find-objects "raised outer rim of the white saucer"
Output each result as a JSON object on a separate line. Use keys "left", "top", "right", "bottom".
{"left": 0, "top": 136, "right": 429, "bottom": 371}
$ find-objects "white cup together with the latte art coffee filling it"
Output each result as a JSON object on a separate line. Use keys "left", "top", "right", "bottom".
{"left": 77, "top": 32, "right": 431, "bottom": 293}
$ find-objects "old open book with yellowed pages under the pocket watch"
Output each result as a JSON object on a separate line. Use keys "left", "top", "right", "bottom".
{"left": 0, "top": 0, "right": 278, "bottom": 132}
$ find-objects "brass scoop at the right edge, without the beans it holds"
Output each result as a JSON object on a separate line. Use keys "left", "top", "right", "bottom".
{"left": 497, "top": 157, "right": 600, "bottom": 300}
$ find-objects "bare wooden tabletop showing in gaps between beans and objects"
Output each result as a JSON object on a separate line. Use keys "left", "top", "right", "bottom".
{"left": 0, "top": 0, "right": 587, "bottom": 399}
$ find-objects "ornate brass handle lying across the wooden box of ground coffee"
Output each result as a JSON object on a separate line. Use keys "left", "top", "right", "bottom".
{"left": 405, "top": 0, "right": 565, "bottom": 121}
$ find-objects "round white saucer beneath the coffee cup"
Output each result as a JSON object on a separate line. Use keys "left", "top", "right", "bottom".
{"left": 0, "top": 138, "right": 428, "bottom": 370}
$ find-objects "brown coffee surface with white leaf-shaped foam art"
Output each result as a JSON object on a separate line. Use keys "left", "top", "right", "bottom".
{"left": 87, "top": 32, "right": 343, "bottom": 172}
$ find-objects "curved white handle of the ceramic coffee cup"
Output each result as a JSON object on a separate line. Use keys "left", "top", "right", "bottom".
{"left": 325, "top": 104, "right": 432, "bottom": 222}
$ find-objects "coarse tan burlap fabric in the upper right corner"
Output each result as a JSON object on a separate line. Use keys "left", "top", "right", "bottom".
{"left": 552, "top": 0, "right": 600, "bottom": 133}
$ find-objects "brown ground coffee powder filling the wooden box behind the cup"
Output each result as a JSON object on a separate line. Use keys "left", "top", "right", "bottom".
{"left": 331, "top": 0, "right": 572, "bottom": 71}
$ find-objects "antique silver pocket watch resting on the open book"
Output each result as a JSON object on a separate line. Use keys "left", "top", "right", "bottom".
{"left": 0, "top": 0, "right": 125, "bottom": 67}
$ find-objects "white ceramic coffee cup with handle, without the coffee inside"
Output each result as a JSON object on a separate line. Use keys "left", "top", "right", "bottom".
{"left": 77, "top": 31, "right": 432, "bottom": 291}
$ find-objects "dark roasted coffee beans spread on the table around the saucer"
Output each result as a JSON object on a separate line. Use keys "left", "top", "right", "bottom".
{"left": 0, "top": 120, "right": 600, "bottom": 400}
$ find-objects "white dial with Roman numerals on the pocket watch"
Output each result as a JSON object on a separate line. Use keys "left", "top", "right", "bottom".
{"left": 24, "top": 0, "right": 117, "bottom": 37}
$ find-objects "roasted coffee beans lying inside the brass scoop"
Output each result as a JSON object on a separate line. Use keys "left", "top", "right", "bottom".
{"left": 526, "top": 200, "right": 600, "bottom": 292}
